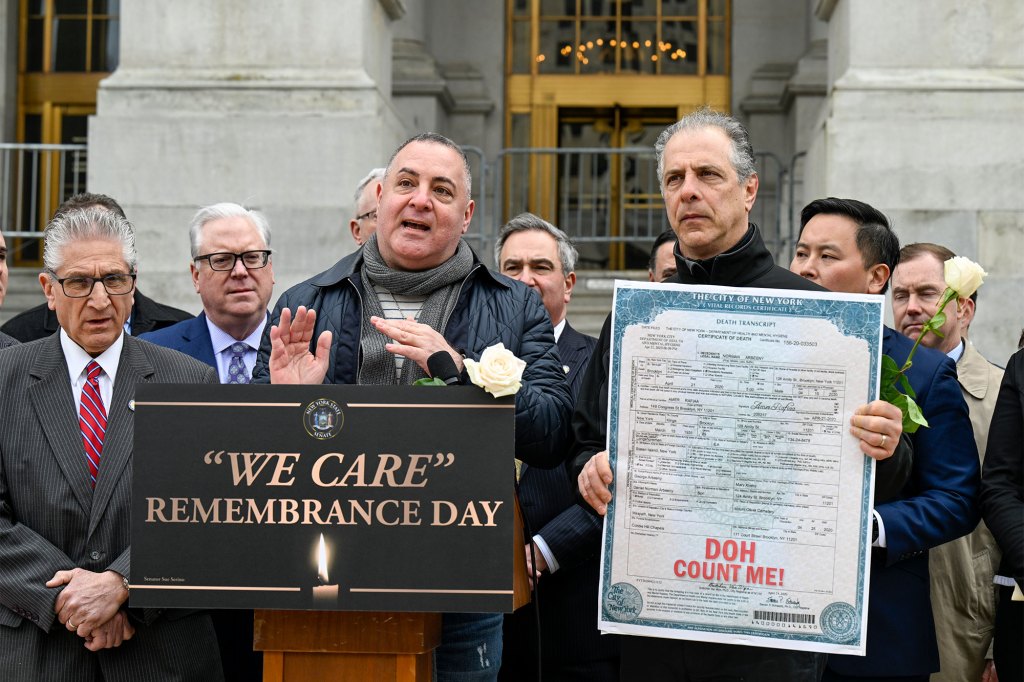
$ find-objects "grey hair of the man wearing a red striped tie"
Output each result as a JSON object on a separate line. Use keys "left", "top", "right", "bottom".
{"left": 43, "top": 207, "right": 138, "bottom": 275}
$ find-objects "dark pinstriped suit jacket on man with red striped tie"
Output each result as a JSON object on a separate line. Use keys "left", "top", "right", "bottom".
{"left": 0, "top": 334, "right": 221, "bottom": 682}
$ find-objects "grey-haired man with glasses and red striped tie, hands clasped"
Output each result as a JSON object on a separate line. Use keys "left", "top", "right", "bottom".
{"left": 0, "top": 209, "right": 221, "bottom": 682}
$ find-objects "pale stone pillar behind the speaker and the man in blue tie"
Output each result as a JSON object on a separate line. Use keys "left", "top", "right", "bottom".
{"left": 89, "top": 0, "right": 406, "bottom": 312}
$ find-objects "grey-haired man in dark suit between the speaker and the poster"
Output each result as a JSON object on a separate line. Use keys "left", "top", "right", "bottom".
{"left": 495, "top": 213, "right": 618, "bottom": 682}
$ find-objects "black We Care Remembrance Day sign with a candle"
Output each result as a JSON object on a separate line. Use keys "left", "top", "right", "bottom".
{"left": 130, "top": 384, "right": 515, "bottom": 611}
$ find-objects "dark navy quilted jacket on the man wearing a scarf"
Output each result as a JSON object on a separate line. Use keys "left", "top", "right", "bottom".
{"left": 253, "top": 244, "right": 572, "bottom": 468}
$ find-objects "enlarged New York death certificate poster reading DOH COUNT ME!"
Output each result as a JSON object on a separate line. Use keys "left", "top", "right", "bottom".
{"left": 599, "top": 282, "right": 884, "bottom": 655}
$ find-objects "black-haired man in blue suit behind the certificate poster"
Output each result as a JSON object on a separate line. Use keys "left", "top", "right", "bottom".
{"left": 790, "top": 198, "right": 979, "bottom": 682}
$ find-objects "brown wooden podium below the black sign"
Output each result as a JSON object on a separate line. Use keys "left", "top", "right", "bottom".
{"left": 253, "top": 609, "right": 441, "bottom": 682}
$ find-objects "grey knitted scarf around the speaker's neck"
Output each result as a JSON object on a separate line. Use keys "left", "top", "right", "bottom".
{"left": 358, "top": 233, "right": 473, "bottom": 386}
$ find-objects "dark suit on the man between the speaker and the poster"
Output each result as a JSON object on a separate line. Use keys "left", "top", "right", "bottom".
{"left": 503, "top": 322, "right": 618, "bottom": 677}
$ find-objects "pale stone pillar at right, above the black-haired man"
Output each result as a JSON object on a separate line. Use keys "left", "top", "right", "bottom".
{"left": 805, "top": 0, "right": 1024, "bottom": 365}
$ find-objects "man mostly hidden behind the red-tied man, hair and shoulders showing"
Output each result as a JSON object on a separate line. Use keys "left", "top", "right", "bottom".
{"left": 0, "top": 193, "right": 193, "bottom": 343}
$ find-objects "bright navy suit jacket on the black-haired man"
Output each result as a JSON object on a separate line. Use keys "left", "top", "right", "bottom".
{"left": 828, "top": 328, "right": 979, "bottom": 677}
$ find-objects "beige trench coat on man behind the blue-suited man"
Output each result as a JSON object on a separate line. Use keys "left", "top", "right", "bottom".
{"left": 928, "top": 339, "right": 1002, "bottom": 682}
